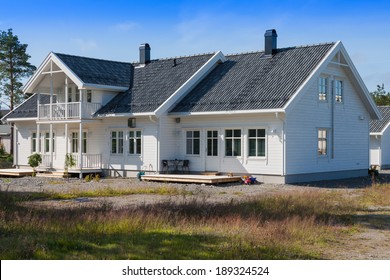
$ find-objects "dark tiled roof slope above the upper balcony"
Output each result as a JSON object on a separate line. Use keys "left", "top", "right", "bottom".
{"left": 55, "top": 53, "right": 132, "bottom": 87}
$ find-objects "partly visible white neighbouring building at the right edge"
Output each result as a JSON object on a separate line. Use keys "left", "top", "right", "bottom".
{"left": 370, "top": 106, "right": 390, "bottom": 169}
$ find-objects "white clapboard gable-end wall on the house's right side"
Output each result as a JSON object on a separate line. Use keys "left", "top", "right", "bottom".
{"left": 286, "top": 63, "right": 370, "bottom": 174}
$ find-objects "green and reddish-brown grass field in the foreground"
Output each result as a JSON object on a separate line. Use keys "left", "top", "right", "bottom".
{"left": 0, "top": 185, "right": 390, "bottom": 260}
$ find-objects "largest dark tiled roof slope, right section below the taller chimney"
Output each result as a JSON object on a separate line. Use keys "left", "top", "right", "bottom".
{"left": 171, "top": 43, "right": 334, "bottom": 113}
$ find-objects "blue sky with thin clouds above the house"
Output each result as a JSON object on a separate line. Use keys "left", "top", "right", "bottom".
{"left": 0, "top": 0, "right": 390, "bottom": 91}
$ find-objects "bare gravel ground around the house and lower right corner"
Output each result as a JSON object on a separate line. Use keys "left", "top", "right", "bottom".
{"left": 0, "top": 171, "right": 390, "bottom": 260}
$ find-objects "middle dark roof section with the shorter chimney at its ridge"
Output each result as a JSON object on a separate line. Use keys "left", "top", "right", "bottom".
{"left": 96, "top": 54, "right": 213, "bottom": 115}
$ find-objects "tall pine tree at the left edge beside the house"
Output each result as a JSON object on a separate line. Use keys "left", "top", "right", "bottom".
{"left": 0, "top": 29, "right": 36, "bottom": 153}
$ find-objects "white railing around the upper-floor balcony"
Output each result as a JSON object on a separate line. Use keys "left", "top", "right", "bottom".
{"left": 38, "top": 102, "right": 102, "bottom": 120}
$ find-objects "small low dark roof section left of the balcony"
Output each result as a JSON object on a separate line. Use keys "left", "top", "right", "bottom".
{"left": 7, "top": 94, "right": 56, "bottom": 119}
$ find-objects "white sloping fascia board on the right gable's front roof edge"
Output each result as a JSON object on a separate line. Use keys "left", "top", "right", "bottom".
{"left": 283, "top": 41, "right": 341, "bottom": 112}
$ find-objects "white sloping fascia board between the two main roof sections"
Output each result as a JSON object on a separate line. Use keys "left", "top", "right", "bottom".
{"left": 154, "top": 51, "right": 226, "bottom": 117}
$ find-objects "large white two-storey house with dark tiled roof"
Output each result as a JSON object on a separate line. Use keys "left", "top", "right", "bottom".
{"left": 1, "top": 30, "right": 380, "bottom": 183}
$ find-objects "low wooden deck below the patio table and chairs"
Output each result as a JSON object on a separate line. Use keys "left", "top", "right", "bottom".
{"left": 141, "top": 174, "right": 241, "bottom": 184}
